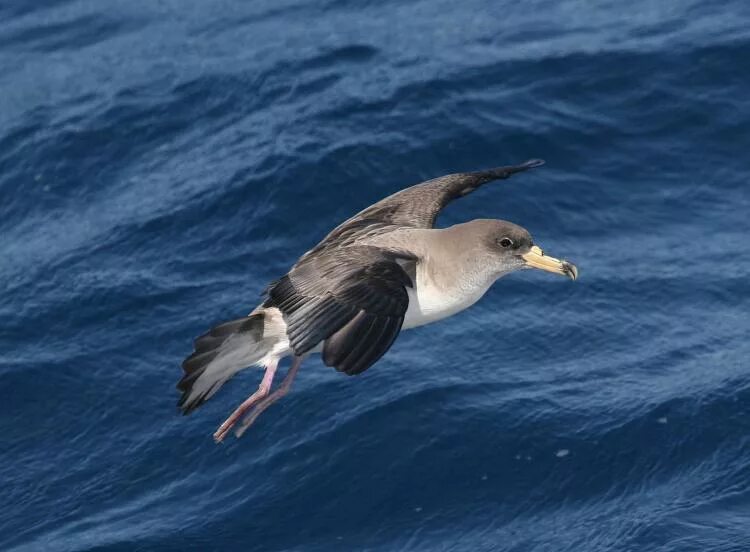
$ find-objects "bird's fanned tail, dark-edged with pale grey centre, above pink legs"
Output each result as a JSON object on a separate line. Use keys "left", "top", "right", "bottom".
{"left": 177, "top": 309, "right": 283, "bottom": 414}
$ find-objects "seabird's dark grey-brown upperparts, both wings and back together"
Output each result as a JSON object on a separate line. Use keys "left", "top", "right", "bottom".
{"left": 265, "top": 159, "right": 543, "bottom": 375}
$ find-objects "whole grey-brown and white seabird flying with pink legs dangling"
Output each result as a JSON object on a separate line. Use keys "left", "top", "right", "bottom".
{"left": 177, "top": 159, "right": 578, "bottom": 443}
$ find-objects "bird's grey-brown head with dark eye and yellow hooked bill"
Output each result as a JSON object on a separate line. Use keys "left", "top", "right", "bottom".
{"left": 474, "top": 220, "right": 578, "bottom": 280}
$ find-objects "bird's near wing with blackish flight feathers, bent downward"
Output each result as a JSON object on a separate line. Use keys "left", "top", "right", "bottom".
{"left": 265, "top": 246, "right": 416, "bottom": 375}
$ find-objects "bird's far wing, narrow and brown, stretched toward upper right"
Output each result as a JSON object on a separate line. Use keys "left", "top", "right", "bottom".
{"left": 344, "top": 159, "right": 544, "bottom": 232}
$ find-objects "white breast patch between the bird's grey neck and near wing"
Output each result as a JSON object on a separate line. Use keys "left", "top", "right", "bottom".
{"left": 402, "top": 268, "right": 495, "bottom": 330}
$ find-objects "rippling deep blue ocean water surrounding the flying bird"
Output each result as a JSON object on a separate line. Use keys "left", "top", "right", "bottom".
{"left": 0, "top": 0, "right": 750, "bottom": 552}
